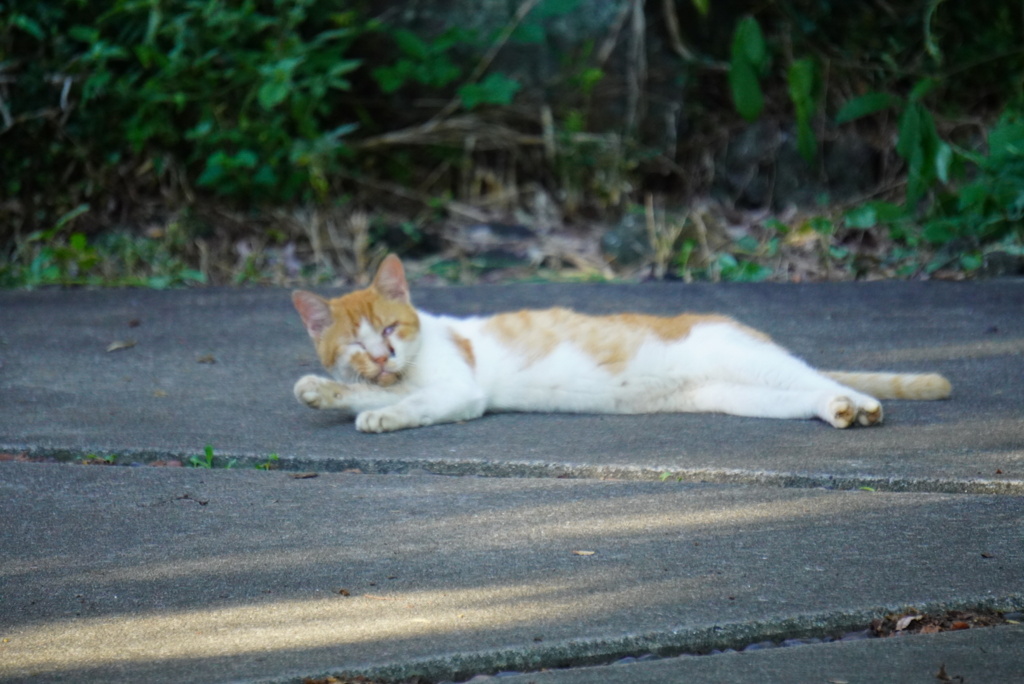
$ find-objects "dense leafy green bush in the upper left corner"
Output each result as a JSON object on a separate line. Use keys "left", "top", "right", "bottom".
{"left": 0, "top": 0, "right": 364, "bottom": 214}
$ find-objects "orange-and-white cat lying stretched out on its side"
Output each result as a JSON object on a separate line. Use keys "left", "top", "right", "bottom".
{"left": 292, "top": 255, "right": 951, "bottom": 432}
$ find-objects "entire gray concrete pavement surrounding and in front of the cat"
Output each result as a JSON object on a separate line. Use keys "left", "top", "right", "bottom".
{"left": 0, "top": 282, "right": 1024, "bottom": 682}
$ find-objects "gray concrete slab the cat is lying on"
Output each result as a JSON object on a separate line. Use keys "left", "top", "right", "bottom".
{"left": 0, "top": 281, "right": 1024, "bottom": 493}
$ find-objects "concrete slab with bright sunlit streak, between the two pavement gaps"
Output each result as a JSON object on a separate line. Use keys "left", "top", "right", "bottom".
{"left": 0, "top": 463, "right": 1024, "bottom": 682}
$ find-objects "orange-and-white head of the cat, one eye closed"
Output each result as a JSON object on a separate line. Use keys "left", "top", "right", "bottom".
{"left": 292, "top": 254, "right": 420, "bottom": 387}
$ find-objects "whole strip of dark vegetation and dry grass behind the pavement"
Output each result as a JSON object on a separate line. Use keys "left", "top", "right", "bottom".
{"left": 0, "top": 0, "right": 1024, "bottom": 287}
